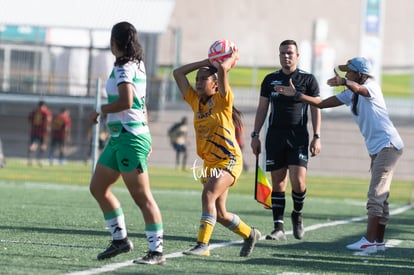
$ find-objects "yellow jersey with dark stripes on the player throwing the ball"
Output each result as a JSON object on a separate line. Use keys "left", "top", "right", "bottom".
{"left": 184, "top": 86, "right": 242, "bottom": 180}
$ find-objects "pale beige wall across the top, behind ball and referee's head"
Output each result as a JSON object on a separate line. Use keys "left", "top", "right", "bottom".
{"left": 159, "top": 0, "right": 414, "bottom": 68}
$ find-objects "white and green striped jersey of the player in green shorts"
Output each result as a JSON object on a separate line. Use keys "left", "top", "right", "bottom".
{"left": 106, "top": 61, "right": 149, "bottom": 137}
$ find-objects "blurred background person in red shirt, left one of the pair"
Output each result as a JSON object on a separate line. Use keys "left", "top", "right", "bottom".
{"left": 28, "top": 100, "right": 52, "bottom": 166}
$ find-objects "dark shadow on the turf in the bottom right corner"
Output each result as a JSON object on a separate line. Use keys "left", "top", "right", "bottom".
{"left": 213, "top": 241, "right": 414, "bottom": 274}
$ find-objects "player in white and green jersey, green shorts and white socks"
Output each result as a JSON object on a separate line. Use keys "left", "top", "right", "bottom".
{"left": 90, "top": 22, "right": 165, "bottom": 264}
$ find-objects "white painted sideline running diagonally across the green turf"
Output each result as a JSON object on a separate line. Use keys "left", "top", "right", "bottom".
{"left": 67, "top": 204, "right": 414, "bottom": 275}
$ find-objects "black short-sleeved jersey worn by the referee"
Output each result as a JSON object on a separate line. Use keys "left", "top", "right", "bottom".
{"left": 260, "top": 69, "right": 319, "bottom": 128}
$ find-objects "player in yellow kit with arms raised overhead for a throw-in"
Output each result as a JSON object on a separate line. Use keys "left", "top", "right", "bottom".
{"left": 174, "top": 48, "right": 260, "bottom": 257}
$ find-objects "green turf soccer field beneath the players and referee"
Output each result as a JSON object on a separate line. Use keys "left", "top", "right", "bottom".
{"left": 0, "top": 163, "right": 414, "bottom": 274}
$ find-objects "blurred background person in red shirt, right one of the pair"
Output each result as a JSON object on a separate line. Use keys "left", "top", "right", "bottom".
{"left": 49, "top": 108, "right": 72, "bottom": 165}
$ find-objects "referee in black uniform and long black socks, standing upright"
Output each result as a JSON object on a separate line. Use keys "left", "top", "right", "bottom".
{"left": 251, "top": 40, "right": 321, "bottom": 240}
